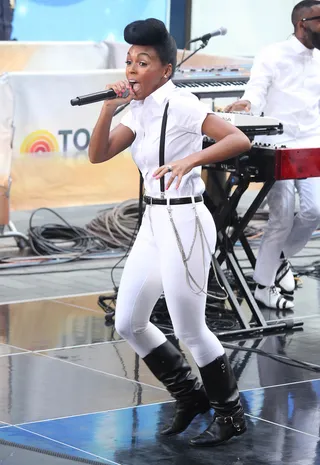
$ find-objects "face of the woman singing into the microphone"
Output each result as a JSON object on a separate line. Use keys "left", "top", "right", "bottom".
{"left": 126, "top": 45, "right": 172, "bottom": 100}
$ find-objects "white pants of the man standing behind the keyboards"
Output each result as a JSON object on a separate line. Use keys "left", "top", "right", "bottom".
{"left": 253, "top": 138, "right": 320, "bottom": 286}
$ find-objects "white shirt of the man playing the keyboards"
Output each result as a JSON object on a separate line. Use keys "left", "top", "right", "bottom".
{"left": 242, "top": 36, "right": 320, "bottom": 144}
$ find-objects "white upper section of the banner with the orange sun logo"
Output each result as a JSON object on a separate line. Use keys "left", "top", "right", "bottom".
{"left": 7, "top": 70, "right": 124, "bottom": 156}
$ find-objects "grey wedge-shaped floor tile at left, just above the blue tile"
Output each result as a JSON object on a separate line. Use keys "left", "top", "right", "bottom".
{"left": 0, "top": 354, "right": 169, "bottom": 424}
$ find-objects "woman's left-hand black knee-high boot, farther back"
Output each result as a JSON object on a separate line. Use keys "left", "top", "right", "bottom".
{"left": 143, "top": 341, "right": 211, "bottom": 435}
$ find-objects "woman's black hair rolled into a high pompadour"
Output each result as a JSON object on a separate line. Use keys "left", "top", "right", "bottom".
{"left": 124, "top": 18, "right": 177, "bottom": 77}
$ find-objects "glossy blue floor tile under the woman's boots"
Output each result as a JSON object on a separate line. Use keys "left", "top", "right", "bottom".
{"left": 23, "top": 395, "right": 320, "bottom": 465}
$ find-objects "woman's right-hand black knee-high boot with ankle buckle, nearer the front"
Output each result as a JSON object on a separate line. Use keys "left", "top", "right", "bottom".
{"left": 190, "top": 354, "right": 247, "bottom": 447}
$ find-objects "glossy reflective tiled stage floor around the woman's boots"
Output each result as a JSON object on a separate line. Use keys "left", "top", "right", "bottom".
{"left": 0, "top": 278, "right": 320, "bottom": 465}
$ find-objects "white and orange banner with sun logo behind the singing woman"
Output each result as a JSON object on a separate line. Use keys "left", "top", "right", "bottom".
{"left": 0, "top": 69, "right": 139, "bottom": 210}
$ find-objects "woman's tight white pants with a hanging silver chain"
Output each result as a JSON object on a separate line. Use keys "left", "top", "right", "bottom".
{"left": 115, "top": 202, "right": 224, "bottom": 367}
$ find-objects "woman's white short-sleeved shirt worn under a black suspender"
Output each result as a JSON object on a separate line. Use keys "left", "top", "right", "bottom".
{"left": 121, "top": 80, "right": 212, "bottom": 197}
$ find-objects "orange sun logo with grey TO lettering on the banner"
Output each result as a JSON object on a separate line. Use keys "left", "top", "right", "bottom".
{"left": 20, "top": 128, "right": 90, "bottom": 153}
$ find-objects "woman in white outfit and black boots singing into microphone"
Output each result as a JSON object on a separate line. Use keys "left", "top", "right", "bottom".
{"left": 89, "top": 19, "right": 251, "bottom": 446}
